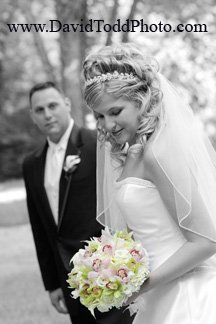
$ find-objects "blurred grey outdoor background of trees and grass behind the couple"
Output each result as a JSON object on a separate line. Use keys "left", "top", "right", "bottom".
{"left": 0, "top": 0, "right": 216, "bottom": 324}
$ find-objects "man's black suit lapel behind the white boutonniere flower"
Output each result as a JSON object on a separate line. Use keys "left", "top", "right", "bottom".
{"left": 58, "top": 124, "right": 82, "bottom": 230}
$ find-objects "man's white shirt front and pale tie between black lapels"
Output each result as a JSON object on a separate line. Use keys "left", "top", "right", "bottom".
{"left": 44, "top": 119, "right": 74, "bottom": 224}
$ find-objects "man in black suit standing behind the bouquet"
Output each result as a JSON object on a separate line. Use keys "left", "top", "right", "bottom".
{"left": 23, "top": 82, "right": 132, "bottom": 324}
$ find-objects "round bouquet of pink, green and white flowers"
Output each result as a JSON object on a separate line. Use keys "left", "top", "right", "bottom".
{"left": 67, "top": 228, "right": 149, "bottom": 316}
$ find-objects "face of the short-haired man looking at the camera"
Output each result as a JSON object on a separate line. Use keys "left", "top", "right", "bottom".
{"left": 31, "top": 88, "right": 70, "bottom": 143}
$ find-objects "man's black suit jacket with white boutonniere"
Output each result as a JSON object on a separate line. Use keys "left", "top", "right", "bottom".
{"left": 23, "top": 125, "right": 101, "bottom": 308}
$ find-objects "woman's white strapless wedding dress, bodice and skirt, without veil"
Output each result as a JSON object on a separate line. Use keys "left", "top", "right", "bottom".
{"left": 115, "top": 177, "right": 216, "bottom": 324}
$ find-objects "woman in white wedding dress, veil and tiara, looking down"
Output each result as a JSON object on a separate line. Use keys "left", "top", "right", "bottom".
{"left": 83, "top": 44, "right": 216, "bottom": 324}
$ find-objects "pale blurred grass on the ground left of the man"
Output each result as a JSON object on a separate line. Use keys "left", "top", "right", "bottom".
{"left": 0, "top": 181, "right": 70, "bottom": 324}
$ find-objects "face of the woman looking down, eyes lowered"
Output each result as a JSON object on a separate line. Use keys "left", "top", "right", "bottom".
{"left": 93, "top": 94, "right": 140, "bottom": 145}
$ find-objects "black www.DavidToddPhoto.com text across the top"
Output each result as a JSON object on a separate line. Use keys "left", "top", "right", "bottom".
{"left": 7, "top": 19, "right": 208, "bottom": 33}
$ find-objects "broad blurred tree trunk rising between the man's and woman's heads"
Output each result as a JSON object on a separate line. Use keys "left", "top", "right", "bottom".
{"left": 55, "top": 0, "right": 87, "bottom": 125}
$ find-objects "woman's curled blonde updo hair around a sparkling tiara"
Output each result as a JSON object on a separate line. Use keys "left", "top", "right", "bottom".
{"left": 83, "top": 44, "right": 162, "bottom": 159}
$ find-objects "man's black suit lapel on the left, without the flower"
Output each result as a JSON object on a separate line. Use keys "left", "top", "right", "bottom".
{"left": 34, "top": 143, "right": 56, "bottom": 228}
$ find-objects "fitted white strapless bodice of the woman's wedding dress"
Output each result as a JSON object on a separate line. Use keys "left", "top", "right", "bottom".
{"left": 115, "top": 177, "right": 214, "bottom": 271}
